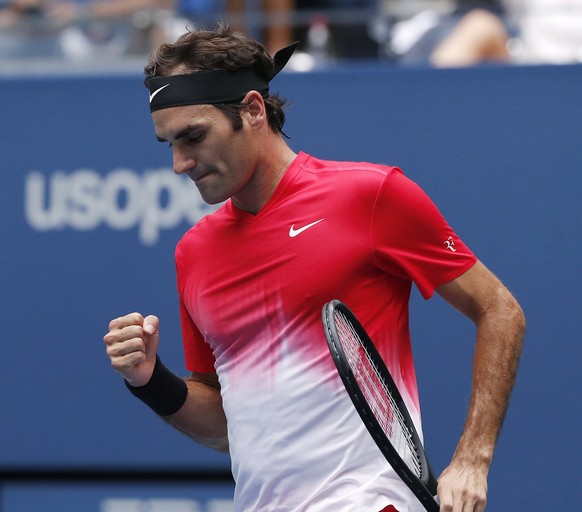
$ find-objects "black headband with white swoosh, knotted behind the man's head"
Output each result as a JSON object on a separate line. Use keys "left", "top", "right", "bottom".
{"left": 148, "top": 42, "right": 299, "bottom": 112}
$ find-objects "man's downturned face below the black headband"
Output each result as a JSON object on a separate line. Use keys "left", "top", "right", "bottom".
{"left": 152, "top": 105, "right": 255, "bottom": 204}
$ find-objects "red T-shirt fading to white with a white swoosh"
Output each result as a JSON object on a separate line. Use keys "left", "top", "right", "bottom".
{"left": 176, "top": 153, "right": 476, "bottom": 512}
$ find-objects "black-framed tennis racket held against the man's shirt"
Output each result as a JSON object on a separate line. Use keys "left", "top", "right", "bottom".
{"left": 322, "top": 300, "right": 439, "bottom": 512}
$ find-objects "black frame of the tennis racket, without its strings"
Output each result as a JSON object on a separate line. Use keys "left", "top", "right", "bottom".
{"left": 322, "top": 300, "right": 439, "bottom": 511}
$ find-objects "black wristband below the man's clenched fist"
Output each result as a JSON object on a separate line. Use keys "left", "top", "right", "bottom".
{"left": 124, "top": 356, "right": 188, "bottom": 416}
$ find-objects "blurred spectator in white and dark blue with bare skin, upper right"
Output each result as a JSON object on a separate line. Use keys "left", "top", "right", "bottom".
{"left": 390, "top": 0, "right": 509, "bottom": 67}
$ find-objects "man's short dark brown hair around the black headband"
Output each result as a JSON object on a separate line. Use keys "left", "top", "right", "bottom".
{"left": 144, "top": 24, "right": 286, "bottom": 133}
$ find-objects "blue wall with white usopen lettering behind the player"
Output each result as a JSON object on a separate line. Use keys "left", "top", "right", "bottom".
{"left": 0, "top": 62, "right": 582, "bottom": 512}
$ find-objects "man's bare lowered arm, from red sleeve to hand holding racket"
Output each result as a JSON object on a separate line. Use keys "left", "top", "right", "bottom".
{"left": 437, "top": 262, "right": 525, "bottom": 512}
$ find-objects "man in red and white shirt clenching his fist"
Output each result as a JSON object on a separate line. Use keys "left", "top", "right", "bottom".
{"left": 104, "top": 27, "right": 524, "bottom": 512}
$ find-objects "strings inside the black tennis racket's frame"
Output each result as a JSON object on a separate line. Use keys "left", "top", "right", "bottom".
{"left": 334, "top": 311, "right": 421, "bottom": 477}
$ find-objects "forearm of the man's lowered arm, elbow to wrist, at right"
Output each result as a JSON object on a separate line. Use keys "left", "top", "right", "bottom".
{"left": 453, "top": 288, "right": 525, "bottom": 468}
